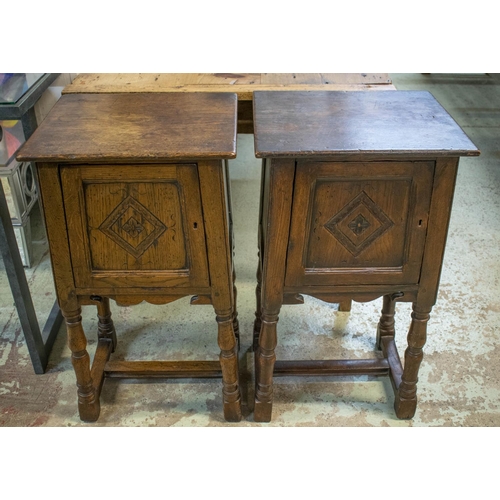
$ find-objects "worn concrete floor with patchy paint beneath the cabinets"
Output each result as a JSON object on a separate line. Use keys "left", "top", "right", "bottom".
{"left": 0, "top": 74, "right": 500, "bottom": 427}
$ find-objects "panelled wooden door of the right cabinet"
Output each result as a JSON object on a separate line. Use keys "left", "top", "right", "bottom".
{"left": 285, "top": 161, "right": 434, "bottom": 286}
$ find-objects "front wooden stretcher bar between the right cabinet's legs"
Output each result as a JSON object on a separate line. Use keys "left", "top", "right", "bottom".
{"left": 274, "top": 359, "right": 389, "bottom": 376}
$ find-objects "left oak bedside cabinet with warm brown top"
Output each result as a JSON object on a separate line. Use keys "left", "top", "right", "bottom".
{"left": 18, "top": 93, "right": 241, "bottom": 422}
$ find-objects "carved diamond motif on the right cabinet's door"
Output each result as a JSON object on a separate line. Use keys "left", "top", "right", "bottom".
{"left": 325, "top": 191, "right": 394, "bottom": 257}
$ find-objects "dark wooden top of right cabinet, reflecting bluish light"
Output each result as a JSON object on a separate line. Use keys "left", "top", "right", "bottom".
{"left": 254, "top": 90, "right": 479, "bottom": 158}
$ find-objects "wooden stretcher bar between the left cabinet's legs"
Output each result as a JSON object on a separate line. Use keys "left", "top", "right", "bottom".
{"left": 104, "top": 360, "right": 222, "bottom": 378}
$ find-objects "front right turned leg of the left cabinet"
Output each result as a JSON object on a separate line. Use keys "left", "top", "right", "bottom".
{"left": 216, "top": 311, "right": 241, "bottom": 422}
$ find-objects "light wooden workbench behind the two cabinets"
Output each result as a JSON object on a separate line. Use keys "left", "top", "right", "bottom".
{"left": 63, "top": 73, "right": 395, "bottom": 134}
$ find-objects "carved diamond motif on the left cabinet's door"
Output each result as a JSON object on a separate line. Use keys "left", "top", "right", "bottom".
{"left": 99, "top": 196, "right": 168, "bottom": 259}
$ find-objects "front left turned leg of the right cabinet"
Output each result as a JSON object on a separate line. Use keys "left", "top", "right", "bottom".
{"left": 254, "top": 311, "right": 278, "bottom": 422}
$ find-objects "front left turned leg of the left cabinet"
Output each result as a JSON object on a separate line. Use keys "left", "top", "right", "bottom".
{"left": 62, "top": 307, "right": 100, "bottom": 422}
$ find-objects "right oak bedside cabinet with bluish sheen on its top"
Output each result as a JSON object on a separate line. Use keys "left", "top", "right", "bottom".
{"left": 254, "top": 91, "right": 479, "bottom": 422}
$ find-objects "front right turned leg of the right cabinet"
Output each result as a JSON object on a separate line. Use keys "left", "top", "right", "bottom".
{"left": 394, "top": 303, "right": 432, "bottom": 418}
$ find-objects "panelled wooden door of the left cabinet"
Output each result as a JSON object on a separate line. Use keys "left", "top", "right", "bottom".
{"left": 61, "top": 164, "right": 209, "bottom": 293}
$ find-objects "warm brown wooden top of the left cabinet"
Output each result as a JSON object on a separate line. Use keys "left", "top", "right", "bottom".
{"left": 17, "top": 93, "right": 237, "bottom": 162}
